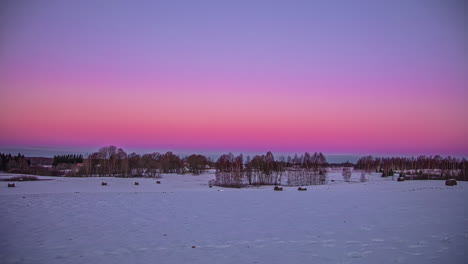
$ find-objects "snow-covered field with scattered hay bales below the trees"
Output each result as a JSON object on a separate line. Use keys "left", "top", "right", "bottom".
{"left": 0, "top": 171, "right": 468, "bottom": 264}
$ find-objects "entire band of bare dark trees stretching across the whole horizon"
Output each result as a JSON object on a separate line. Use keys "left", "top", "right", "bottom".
{"left": 0, "top": 146, "right": 468, "bottom": 187}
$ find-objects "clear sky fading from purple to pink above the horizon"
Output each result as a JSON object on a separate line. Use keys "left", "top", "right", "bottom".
{"left": 0, "top": 0, "right": 468, "bottom": 156}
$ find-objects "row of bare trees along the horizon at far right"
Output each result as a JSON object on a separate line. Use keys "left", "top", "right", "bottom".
{"left": 355, "top": 155, "right": 468, "bottom": 181}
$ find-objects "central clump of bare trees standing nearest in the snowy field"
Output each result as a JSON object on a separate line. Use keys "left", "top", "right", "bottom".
{"left": 212, "top": 152, "right": 327, "bottom": 187}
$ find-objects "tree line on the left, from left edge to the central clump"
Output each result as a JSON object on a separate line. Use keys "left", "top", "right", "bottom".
{"left": 0, "top": 146, "right": 213, "bottom": 177}
